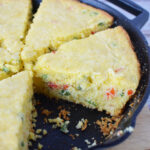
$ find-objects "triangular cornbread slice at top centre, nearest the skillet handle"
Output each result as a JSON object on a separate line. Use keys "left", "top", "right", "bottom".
{"left": 21, "top": 0, "right": 113, "bottom": 70}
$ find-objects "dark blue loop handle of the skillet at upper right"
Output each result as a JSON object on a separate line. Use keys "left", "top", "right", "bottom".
{"left": 107, "top": 0, "right": 149, "bottom": 29}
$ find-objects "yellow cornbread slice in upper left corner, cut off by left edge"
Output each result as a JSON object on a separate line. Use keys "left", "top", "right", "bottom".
{"left": 0, "top": 0, "right": 31, "bottom": 79}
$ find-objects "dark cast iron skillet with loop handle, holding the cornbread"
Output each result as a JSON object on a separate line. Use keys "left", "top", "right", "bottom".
{"left": 30, "top": 0, "right": 150, "bottom": 150}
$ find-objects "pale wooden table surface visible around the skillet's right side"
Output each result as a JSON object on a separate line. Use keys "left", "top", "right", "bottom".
{"left": 100, "top": 0, "right": 150, "bottom": 150}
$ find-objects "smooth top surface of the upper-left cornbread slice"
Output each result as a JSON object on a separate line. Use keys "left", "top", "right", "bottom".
{"left": 0, "top": 0, "right": 31, "bottom": 52}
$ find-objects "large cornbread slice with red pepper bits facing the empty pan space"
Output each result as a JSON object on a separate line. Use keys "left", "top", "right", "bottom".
{"left": 34, "top": 26, "right": 140, "bottom": 116}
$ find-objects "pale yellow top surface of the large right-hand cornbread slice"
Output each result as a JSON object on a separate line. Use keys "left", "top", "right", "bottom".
{"left": 35, "top": 26, "right": 140, "bottom": 81}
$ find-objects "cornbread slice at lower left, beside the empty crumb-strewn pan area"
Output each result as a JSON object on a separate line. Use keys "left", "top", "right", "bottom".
{"left": 0, "top": 71, "right": 33, "bottom": 150}
